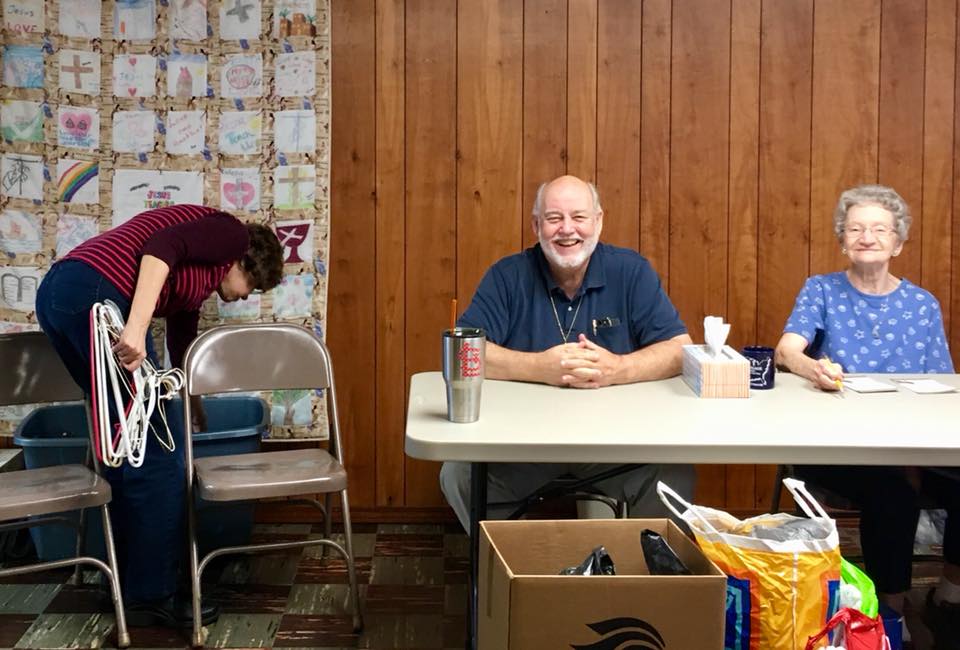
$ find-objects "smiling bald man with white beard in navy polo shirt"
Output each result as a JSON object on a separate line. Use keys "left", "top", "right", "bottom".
{"left": 440, "top": 176, "right": 694, "bottom": 530}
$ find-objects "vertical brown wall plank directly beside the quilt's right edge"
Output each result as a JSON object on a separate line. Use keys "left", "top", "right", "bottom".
{"left": 327, "top": 0, "right": 376, "bottom": 507}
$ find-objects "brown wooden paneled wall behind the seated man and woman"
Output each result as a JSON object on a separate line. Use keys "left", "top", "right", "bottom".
{"left": 329, "top": 0, "right": 960, "bottom": 508}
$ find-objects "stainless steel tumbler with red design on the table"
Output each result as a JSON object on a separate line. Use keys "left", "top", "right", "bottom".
{"left": 443, "top": 327, "right": 487, "bottom": 422}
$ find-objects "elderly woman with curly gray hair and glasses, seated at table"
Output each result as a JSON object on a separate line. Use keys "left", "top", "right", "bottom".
{"left": 776, "top": 185, "right": 960, "bottom": 648}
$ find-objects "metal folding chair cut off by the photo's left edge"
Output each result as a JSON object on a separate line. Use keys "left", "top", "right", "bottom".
{"left": 0, "top": 332, "right": 130, "bottom": 648}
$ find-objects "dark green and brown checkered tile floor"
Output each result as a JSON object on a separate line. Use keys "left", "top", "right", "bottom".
{"left": 0, "top": 524, "right": 469, "bottom": 650}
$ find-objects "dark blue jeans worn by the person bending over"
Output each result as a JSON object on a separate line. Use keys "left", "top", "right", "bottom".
{"left": 36, "top": 260, "right": 186, "bottom": 604}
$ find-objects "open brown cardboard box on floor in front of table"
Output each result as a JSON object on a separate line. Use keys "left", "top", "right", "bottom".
{"left": 477, "top": 519, "right": 727, "bottom": 650}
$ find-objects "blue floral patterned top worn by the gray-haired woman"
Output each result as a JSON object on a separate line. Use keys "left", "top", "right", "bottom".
{"left": 783, "top": 272, "right": 953, "bottom": 373}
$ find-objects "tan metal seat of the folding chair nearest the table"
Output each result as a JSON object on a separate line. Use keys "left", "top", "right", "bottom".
{"left": 193, "top": 449, "right": 347, "bottom": 501}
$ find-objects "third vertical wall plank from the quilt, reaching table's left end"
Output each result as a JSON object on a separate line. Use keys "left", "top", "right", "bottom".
{"left": 404, "top": 0, "right": 457, "bottom": 506}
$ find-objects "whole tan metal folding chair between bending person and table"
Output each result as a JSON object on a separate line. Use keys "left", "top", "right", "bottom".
{"left": 183, "top": 323, "right": 363, "bottom": 646}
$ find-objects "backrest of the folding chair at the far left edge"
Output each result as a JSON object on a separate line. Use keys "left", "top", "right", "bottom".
{"left": 0, "top": 332, "right": 83, "bottom": 406}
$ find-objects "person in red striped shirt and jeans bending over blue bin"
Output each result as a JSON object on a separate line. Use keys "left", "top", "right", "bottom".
{"left": 36, "top": 205, "right": 283, "bottom": 626}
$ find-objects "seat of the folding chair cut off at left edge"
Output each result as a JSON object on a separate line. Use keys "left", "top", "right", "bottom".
{"left": 0, "top": 465, "right": 111, "bottom": 520}
